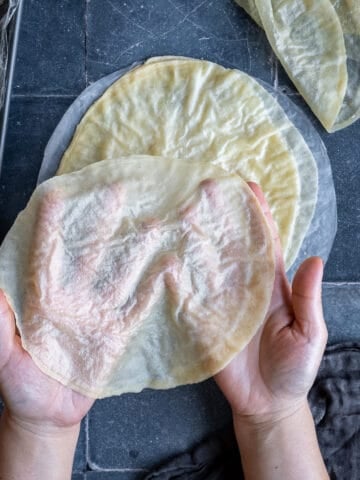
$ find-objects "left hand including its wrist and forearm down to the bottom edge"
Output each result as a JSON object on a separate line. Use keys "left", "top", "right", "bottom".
{"left": 0, "top": 291, "right": 93, "bottom": 480}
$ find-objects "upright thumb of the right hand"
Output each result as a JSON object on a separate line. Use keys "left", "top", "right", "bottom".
{"left": 292, "top": 257, "right": 327, "bottom": 346}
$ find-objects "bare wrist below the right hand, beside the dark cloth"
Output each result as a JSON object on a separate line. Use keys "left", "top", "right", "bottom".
{"left": 234, "top": 402, "right": 329, "bottom": 480}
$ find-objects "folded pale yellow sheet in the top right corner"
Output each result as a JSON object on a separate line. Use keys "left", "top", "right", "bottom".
{"left": 235, "top": 0, "right": 360, "bottom": 132}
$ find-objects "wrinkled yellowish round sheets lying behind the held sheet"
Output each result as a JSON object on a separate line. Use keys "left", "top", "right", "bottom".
{"left": 58, "top": 57, "right": 317, "bottom": 267}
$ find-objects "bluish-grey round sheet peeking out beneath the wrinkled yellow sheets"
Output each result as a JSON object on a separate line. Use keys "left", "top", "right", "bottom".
{"left": 38, "top": 63, "right": 337, "bottom": 279}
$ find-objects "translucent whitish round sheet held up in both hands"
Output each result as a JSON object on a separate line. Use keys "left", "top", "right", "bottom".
{"left": 0, "top": 156, "right": 275, "bottom": 398}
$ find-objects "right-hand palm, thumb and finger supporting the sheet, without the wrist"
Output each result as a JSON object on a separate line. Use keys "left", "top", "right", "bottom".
{"left": 215, "top": 184, "right": 327, "bottom": 424}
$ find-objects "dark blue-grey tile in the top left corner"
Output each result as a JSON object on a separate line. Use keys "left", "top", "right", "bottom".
{"left": 13, "top": 0, "right": 85, "bottom": 95}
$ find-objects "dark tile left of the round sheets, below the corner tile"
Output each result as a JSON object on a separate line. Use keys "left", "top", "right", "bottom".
{"left": 0, "top": 97, "right": 73, "bottom": 241}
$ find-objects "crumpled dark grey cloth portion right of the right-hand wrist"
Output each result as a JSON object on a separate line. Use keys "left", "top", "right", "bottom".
{"left": 309, "top": 344, "right": 360, "bottom": 480}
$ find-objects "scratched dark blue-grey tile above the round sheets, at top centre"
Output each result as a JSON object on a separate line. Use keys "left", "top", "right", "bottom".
{"left": 87, "top": 0, "right": 272, "bottom": 82}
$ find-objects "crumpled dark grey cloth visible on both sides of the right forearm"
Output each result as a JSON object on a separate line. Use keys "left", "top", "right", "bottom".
{"left": 145, "top": 343, "right": 360, "bottom": 480}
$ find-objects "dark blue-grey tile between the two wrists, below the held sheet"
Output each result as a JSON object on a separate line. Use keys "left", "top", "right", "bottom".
{"left": 89, "top": 380, "right": 231, "bottom": 469}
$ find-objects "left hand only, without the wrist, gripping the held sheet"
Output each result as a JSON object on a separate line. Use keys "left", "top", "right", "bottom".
{"left": 0, "top": 291, "right": 94, "bottom": 431}
